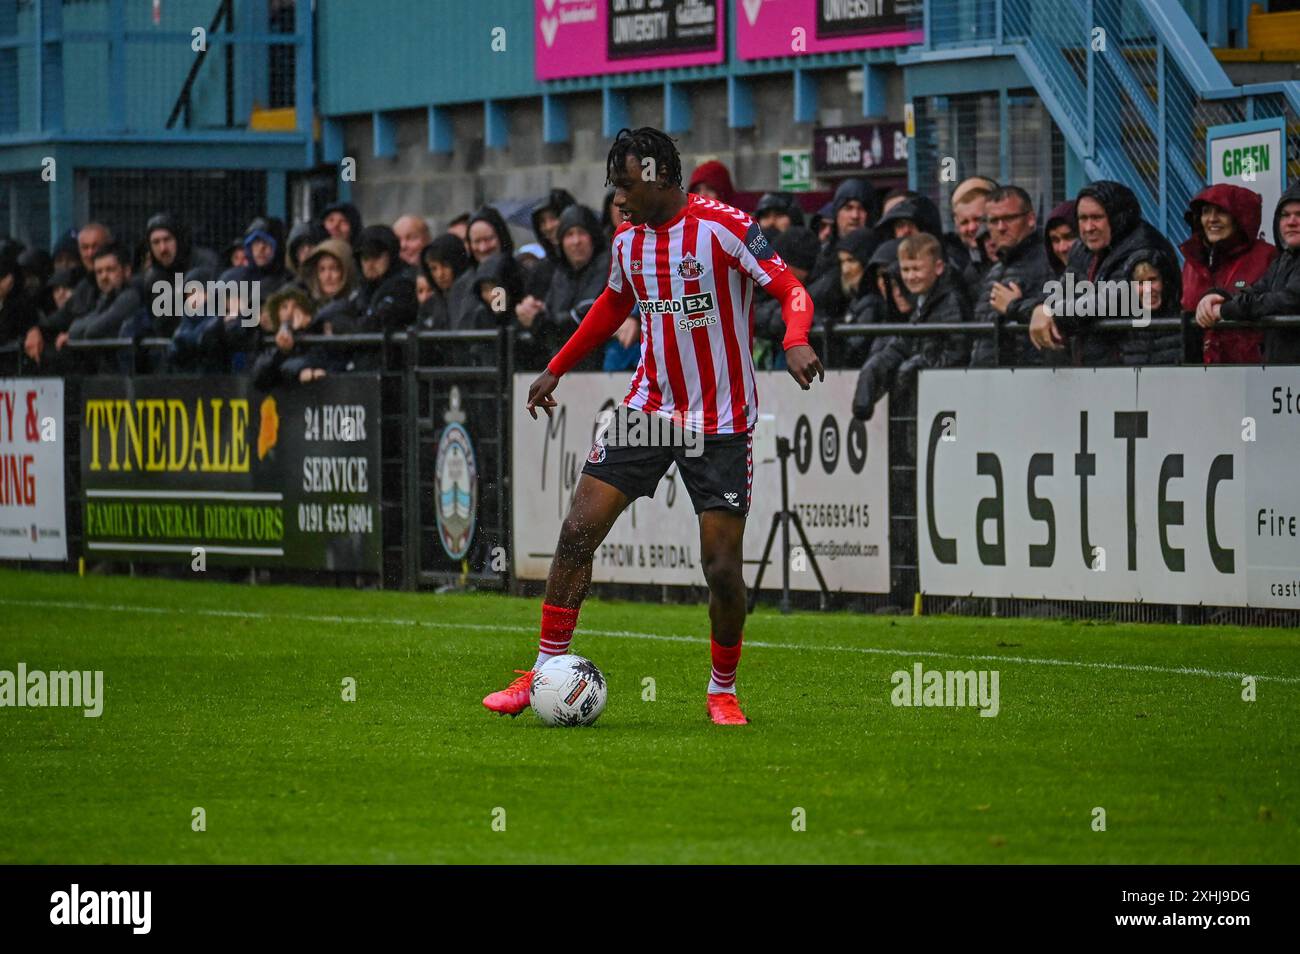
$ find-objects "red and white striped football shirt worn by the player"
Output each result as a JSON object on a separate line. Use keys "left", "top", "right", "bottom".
{"left": 608, "top": 194, "right": 787, "bottom": 434}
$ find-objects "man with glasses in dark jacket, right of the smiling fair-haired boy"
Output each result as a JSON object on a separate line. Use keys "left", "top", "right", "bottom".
{"left": 971, "top": 186, "right": 1053, "bottom": 368}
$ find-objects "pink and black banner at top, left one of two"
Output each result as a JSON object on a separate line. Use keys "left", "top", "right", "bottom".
{"left": 534, "top": 0, "right": 727, "bottom": 79}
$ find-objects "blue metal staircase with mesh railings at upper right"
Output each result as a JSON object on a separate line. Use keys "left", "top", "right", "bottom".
{"left": 900, "top": 0, "right": 1300, "bottom": 234}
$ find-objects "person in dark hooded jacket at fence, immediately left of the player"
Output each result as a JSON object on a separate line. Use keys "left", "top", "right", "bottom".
{"left": 542, "top": 203, "right": 616, "bottom": 370}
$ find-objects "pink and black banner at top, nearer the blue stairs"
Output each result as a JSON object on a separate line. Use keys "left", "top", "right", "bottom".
{"left": 736, "top": 0, "right": 924, "bottom": 60}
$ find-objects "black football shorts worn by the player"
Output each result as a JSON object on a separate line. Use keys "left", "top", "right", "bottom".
{"left": 582, "top": 404, "right": 754, "bottom": 516}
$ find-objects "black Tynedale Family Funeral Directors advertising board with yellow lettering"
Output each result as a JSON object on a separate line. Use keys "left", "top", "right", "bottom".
{"left": 81, "top": 376, "right": 382, "bottom": 572}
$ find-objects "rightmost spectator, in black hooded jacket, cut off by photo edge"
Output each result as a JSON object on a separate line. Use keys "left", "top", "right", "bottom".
{"left": 1196, "top": 183, "right": 1300, "bottom": 364}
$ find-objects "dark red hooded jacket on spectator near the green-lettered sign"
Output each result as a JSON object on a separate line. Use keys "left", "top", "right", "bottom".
{"left": 1179, "top": 185, "right": 1278, "bottom": 364}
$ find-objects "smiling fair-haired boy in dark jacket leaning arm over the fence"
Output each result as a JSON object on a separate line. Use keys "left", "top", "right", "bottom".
{"left": 853, "top": 233, "right": 971, "bottom": 421}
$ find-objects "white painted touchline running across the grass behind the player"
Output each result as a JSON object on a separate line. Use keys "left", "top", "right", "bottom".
{"left": 0, "top": 599, "right": 1300, "bottom": 685}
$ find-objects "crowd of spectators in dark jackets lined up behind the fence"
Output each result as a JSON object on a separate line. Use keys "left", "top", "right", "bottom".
{"left": 0, "top": 161, "right": 1300, "bottom": 419}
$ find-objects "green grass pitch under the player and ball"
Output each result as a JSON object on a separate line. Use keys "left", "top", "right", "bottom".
{"left": 0, "top": 571, "right": 1300, "bottom": 864}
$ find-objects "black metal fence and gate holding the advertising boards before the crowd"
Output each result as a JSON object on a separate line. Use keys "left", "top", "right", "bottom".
{"left": 0, "top": 316, "right": 1300, "bottom": 626}
